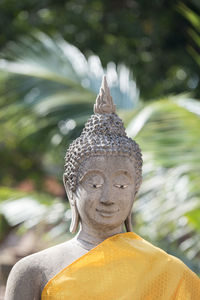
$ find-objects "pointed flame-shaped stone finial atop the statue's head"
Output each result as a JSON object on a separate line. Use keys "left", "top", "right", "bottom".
{"left": 94, "top": 75, "right": 116, "bottom": 114}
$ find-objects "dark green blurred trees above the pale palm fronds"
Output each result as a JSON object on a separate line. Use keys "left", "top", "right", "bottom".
{"left": 0, "top": 0, "right": 200, "bottom": 100}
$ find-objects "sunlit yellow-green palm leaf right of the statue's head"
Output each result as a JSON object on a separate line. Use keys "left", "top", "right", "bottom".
{"left": 127, "top": 96, "right": 200, "bottom": 272}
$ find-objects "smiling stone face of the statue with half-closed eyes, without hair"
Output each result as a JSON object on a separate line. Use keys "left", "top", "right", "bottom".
{"left": 74, "top": 156, "right": 136, "bottom": 229}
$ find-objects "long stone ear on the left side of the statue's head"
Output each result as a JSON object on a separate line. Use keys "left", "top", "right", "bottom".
{"left": 63, "top": 174, "right": 80, "bottom": 233}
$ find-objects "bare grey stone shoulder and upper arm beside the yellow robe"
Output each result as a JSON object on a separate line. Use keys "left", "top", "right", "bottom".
{"left": 5, "top": 239, "right": 84, "bottom": 300}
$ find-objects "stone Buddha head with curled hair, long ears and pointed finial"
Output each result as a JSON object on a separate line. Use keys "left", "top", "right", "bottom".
{"left": 63, "top": 76, "right": 142, "bottom": 233}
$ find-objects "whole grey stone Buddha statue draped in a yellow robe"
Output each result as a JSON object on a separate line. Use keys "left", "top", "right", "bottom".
{"left": 5, "top": 77, "right": 200, "bottom": 300}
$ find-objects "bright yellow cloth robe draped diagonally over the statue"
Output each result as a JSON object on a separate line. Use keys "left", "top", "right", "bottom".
{"left": 41, "top": 232, "right": 200, "bottom": 300}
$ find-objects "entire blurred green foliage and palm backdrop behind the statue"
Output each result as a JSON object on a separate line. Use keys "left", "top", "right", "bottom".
{"left": 0, "top": 0, "right": 200, "bottom": 273}
